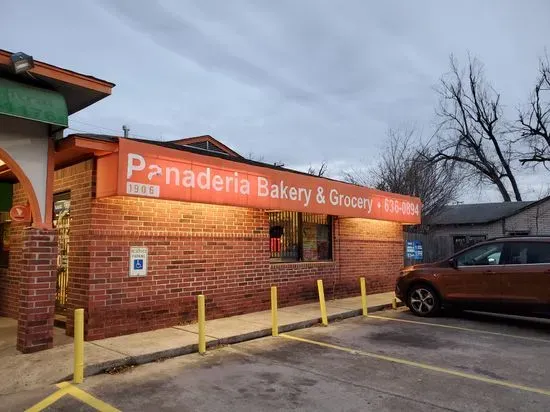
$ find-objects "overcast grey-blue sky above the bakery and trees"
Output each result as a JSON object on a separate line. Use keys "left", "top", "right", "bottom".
{"left": 0, "top": 0, "right": 550, "bottom": 201}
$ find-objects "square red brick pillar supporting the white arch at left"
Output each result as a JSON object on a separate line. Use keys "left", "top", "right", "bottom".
{"left": 17, "top": 228, "right": 57, "bottom": 353}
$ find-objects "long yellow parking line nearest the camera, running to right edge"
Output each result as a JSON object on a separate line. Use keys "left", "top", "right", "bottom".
{"left": 279, "top": 333, "right": 550, "bottom": 396}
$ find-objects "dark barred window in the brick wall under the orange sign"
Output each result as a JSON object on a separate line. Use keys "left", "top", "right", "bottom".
{"left": 269, "top": 212, "right": 332, "bottom": 262}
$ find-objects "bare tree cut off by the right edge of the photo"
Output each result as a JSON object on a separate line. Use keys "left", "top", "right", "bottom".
{"left": 517, "top": 55, "right": 550, "bottom": 170}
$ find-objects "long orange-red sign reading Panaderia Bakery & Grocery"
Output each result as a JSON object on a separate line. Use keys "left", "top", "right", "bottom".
{"left": 96, "top": 139, "right": 421, "bottom": 224}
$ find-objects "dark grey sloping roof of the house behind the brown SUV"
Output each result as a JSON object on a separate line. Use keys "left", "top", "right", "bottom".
{"left": 426, "top": 202, "right": 536, "bottom": 225}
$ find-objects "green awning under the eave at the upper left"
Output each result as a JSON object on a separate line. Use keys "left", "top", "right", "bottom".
{"left": 0, "top": 78, "right": 69, "bottom": 127}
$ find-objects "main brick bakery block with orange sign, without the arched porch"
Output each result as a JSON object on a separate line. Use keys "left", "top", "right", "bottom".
{"left": 0, "top": 135, "right": 420, "bottom": 340}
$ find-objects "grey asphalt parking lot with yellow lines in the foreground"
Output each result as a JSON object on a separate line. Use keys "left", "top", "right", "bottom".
{"left": 10, "top": 310, "right": 550, "bottom": 412}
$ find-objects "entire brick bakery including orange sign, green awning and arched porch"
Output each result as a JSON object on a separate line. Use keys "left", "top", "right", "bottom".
{"left": 0, "top": 50, "right": 421, "bottom": 352}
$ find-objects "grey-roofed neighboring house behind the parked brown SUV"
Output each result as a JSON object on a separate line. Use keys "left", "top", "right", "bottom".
{"left": 413, "top": 197, "right": 550, "bottom": 261}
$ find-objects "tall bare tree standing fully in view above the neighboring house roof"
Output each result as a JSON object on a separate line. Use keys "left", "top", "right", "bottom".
{"left": 430, "top": 56, "right": 521, "bottom": 202}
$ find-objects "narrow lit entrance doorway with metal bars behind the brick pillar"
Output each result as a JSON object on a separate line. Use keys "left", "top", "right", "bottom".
{"left": 53, "top": 192, "right": 71, "bottom": 315}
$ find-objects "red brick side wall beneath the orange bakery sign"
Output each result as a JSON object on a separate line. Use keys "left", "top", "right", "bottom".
{"left": 0, "top": 161, "right": 403, "bottom": 340}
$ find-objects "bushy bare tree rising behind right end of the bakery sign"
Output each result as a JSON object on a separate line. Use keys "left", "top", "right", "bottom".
{"left": 344, "top": 130, "right": 460, "bottom": 216}
